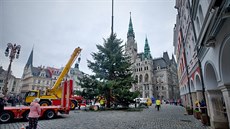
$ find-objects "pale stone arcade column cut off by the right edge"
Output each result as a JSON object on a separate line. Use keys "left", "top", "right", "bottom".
{"left": 221, "top": 85, "right": 230, "bottom": 128}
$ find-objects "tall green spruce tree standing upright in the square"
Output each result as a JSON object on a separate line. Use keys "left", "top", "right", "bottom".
{"left": 87, "top": 34, "right": 138, "bottom": 108}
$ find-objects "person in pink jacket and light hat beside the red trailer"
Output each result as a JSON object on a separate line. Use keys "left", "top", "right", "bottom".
{"left": 28, "top": 98, "right": 41, "bottom": 129}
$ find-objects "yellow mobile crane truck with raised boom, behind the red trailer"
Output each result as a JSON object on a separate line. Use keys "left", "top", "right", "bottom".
{"left": 25, "top": 47, "right": 82, "bottom": 110}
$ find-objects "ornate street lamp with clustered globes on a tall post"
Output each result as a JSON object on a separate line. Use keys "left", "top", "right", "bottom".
{"left": 2, "top": 43, "right": 21, "bottom": 95}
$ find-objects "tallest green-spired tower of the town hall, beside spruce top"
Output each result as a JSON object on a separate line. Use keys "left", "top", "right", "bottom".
{"left": 125, "top": 12, "right": 137, "bottom": 63}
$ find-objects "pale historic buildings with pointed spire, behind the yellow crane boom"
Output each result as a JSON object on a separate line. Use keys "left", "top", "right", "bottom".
{"left": 21, "top": 50, "right": 83, "bottom": 93}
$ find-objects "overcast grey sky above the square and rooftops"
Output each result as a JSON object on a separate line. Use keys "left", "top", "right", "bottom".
{"left": 0, "top": 0, "right": 176, "bottom": 78}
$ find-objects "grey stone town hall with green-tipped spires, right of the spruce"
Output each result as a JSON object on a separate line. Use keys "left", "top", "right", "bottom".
{"left": 125, "top": 16, "right": 179, "bottom": 100}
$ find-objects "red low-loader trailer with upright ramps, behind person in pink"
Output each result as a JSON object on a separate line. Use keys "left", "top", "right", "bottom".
{"left": 0, "top": 80, "right": 73, "bottom": 123}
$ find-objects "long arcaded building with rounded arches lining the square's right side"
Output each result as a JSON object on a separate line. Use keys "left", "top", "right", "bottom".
{"left": 174, "top": 0, "right": 230, "bottom": 129}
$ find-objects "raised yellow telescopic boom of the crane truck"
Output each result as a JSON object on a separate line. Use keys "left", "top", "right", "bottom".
{"left": 50, "top": 47, "right": 82, "bottom": 92}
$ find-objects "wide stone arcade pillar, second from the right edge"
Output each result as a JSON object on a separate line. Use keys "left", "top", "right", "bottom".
{"left": 207, "top": 90, "right": 228, "bottom": 129}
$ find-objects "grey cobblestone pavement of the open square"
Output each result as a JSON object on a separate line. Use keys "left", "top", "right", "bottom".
{"left": 0, "top": 105, "right": 211, "bottom": 129}
